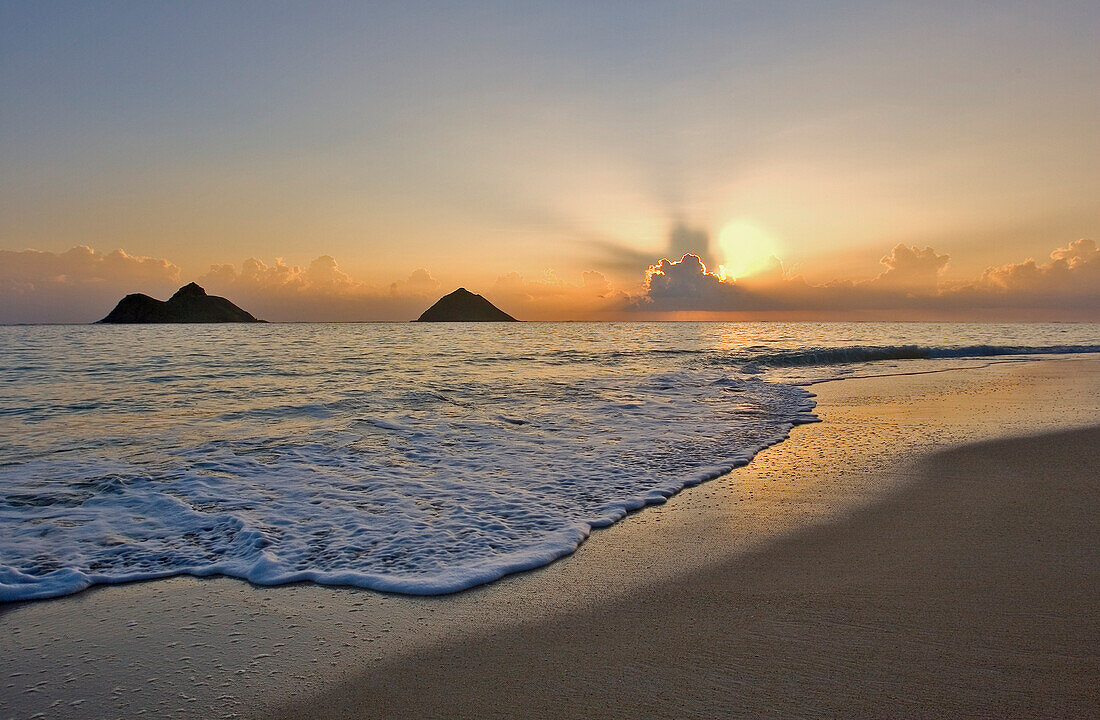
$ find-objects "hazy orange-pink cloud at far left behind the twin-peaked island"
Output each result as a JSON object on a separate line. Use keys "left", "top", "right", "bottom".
{"left": 0, "top": 245, "right": 179, "bottom": 322}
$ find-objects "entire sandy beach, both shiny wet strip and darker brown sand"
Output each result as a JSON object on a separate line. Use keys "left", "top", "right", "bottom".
{"left": 0, "top": 359, "right": 1100, "bottom": 718}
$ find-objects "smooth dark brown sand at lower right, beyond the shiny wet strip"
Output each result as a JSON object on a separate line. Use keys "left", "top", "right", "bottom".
{"left": 285, "top": 428, "right": 1100, "bottom": 718}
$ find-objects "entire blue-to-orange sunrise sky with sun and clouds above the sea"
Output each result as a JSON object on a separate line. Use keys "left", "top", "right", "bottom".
{"left": 0, "top": 0, "right": 1100, "bottom": 322}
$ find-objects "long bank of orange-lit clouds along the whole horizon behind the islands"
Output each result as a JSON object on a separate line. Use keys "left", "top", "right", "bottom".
{"left": 0, "top": 236, "right": 1100, "bottom": 323}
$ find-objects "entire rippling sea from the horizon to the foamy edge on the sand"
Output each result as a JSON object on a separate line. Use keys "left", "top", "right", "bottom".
{"left": 0, "top": 323, "right": 1100, "bottom": 600}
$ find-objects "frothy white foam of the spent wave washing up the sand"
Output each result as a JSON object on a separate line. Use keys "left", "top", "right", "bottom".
{"left": 0, "top": 372, "right": 812, "bottom": 600}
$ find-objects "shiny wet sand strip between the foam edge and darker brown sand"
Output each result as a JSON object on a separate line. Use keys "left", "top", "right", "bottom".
{"left": 0, "top": 359, "right": 1100, "bottom": 718}
